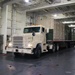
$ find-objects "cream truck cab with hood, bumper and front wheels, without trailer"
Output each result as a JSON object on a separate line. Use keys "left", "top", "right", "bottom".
{"left": 6, "top": 25, "right": 48, "bottom": 57}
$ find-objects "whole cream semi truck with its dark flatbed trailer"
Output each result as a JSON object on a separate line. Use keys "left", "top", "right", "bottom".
{"left": 6, "top": 25, "right": 75, "bottom": 58}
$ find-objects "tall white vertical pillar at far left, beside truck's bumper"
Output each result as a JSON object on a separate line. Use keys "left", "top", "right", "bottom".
{"left": 1, "top": 5, "right": 8, "bottom": 54}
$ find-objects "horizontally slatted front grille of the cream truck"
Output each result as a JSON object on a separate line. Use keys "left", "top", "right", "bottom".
{"left": 13, "top": 36, "right": 23, "bottom": 48}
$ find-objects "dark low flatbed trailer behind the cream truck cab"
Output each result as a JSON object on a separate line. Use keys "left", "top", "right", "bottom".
{"left": 47, "top": 40, "right": 75, "bottom": 51}
